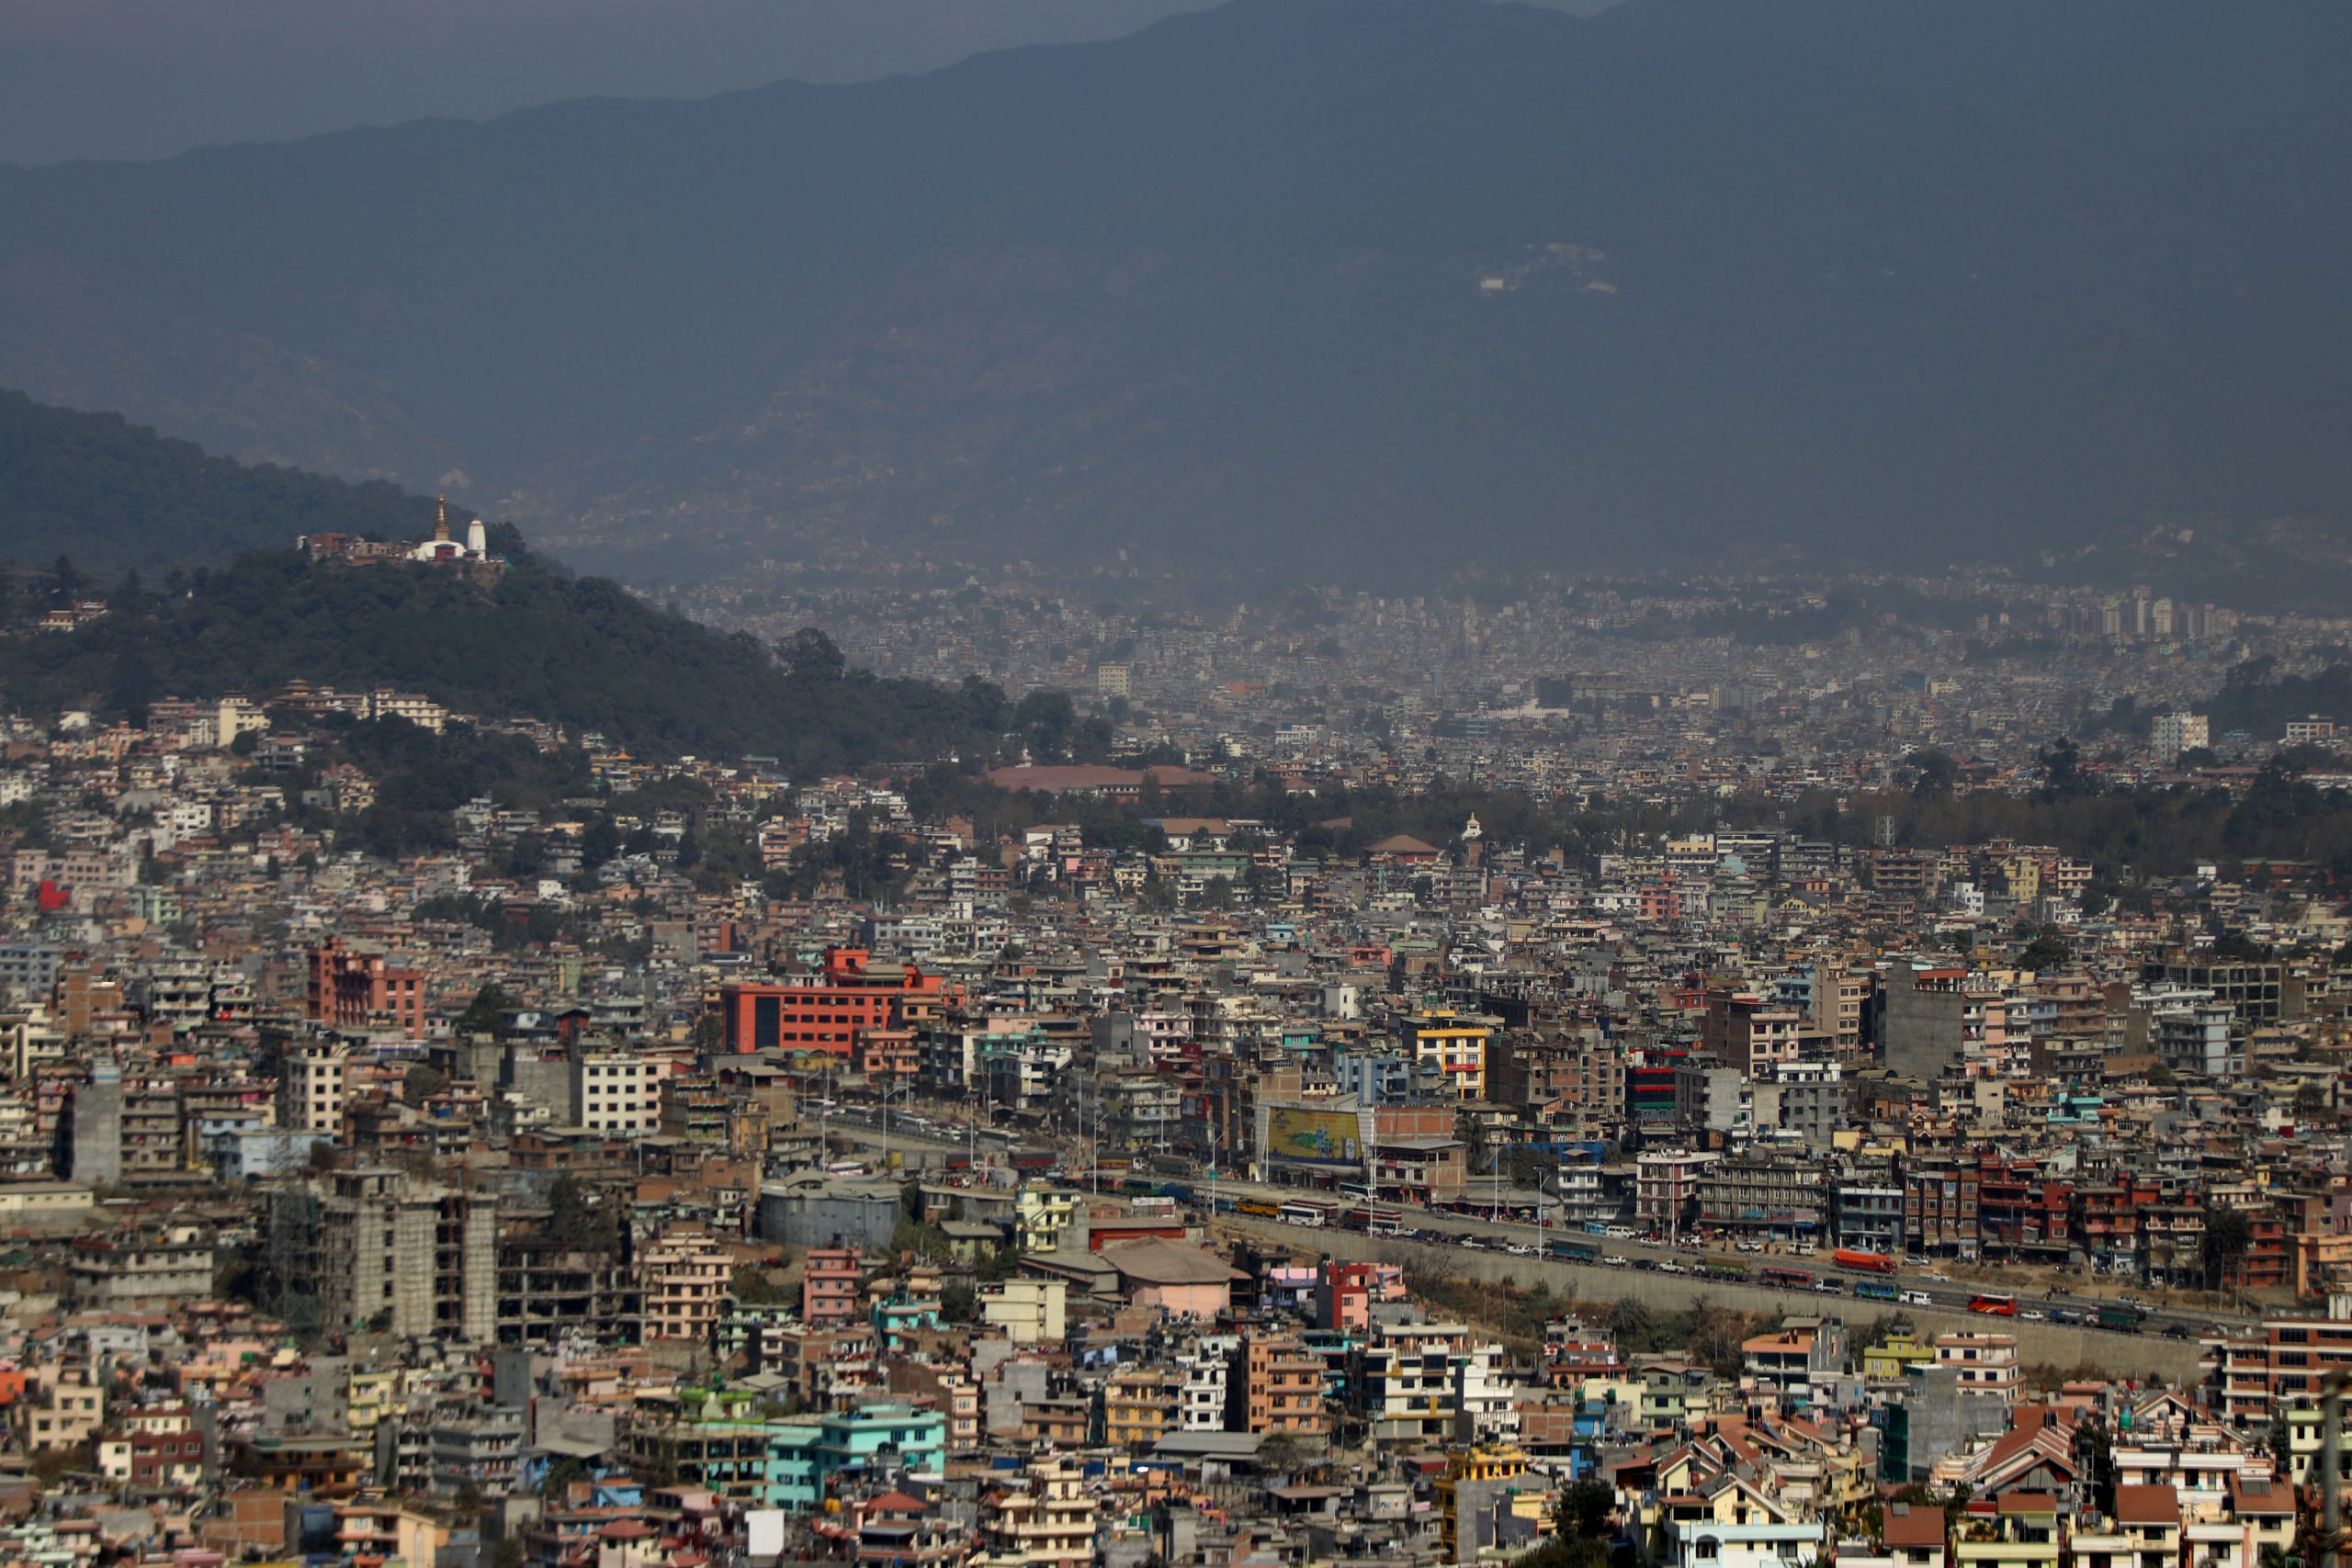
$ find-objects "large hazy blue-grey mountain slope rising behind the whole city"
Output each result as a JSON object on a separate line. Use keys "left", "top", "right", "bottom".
{"left": 0, "top": 0, "right": 2352, "bottom": 579}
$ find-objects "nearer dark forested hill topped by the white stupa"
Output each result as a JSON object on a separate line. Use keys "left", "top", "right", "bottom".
{"left": 0, "top": 550, "right": 1013, "bottom": 773}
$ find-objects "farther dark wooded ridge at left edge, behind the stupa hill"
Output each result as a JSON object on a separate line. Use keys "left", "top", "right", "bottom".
{"left": 0, "top": 390, "right": 456, "bottom": 579}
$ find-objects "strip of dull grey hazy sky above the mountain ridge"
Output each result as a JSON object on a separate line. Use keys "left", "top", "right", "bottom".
{"left": 0, "top": 0, "right": 1606, "bottom": 163}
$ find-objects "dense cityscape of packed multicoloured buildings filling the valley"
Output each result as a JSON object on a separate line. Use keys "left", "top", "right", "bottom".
{"left": 0, "top": 514, "right": 2352, "bottom": 1568}
